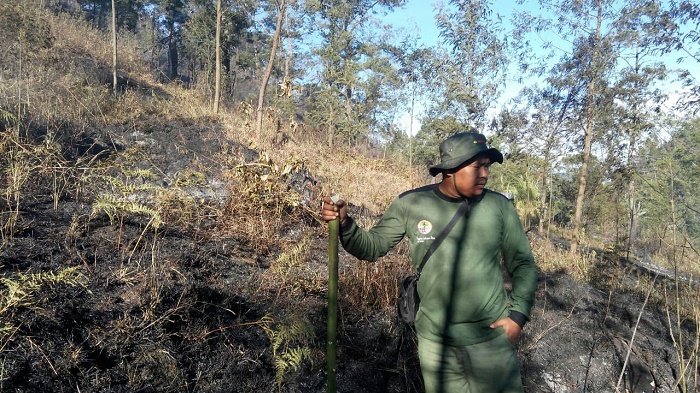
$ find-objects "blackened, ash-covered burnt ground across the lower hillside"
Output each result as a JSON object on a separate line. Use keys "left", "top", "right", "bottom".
{"left": 0, "top": 121, "right": 695, "bottom": 393}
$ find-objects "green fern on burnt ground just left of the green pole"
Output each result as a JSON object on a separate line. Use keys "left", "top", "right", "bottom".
{"left": 262, "top": 313, "right": 316, "bottom": 389}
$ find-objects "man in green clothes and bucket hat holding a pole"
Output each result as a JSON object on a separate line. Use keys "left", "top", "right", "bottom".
{"left": 322, "top": 133, "right": 537, "bottom": 393}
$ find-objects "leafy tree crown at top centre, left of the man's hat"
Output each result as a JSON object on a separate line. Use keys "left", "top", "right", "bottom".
{"left": 304, "top": 0, "right": 408, "bottom": 144}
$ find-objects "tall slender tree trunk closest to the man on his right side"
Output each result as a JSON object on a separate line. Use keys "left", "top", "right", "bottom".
{"left": 569, "top": 0, "right": 603, "bottom": 254}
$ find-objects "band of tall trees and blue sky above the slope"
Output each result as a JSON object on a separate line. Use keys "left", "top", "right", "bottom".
{"left": 0, "top": 0, "right": 700, "bottom": 264}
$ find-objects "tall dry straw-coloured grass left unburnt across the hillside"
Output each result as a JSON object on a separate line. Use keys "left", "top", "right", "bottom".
{"left": 0, "top": 5, "right": 700, "bottom": 388}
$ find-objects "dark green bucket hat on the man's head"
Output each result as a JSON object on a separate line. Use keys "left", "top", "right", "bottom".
{"left": 429, "top": 132, "right": 503, "bottom": 176}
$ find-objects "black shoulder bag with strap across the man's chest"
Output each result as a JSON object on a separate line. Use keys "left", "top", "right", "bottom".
{"left": 397, "top": 200, "right": 469, "bottom": 325}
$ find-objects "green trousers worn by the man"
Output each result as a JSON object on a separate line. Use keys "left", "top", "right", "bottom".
{"left": 418, "top": 334, "right": 523, "bottom": 393}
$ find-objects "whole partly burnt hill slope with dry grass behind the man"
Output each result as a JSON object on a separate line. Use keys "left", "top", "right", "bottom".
{"left": 0, "top": 3, "right": 698, "bottom": 392}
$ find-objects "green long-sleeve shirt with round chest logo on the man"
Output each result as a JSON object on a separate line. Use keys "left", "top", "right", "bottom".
{"left": 340, "top": 184, "right": 537, "bottom": 346}
